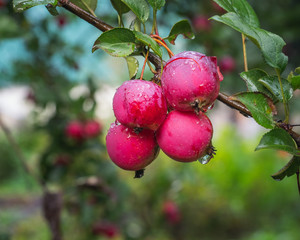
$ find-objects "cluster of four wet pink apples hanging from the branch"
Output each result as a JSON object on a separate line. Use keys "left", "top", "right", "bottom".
{"left": 106, "top": 51, "right": 223, "bottom": 174}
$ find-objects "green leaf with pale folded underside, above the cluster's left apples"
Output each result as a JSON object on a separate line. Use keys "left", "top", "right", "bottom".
{"left": 92, "top": 28, "right": 135, "bottom": 57}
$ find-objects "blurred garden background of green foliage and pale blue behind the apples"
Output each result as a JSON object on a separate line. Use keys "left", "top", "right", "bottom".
{"left": 0, "top": 0, "right": 300, "bottom": 240}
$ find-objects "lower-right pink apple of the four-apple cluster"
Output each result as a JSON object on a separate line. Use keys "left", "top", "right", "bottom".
{"left": 156, "top": 110, "right": 213, "bottom": 162}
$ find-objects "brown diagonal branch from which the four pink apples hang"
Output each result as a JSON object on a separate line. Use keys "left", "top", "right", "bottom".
{"left": 58, "top": 0, "right": 300, "bottom": 147}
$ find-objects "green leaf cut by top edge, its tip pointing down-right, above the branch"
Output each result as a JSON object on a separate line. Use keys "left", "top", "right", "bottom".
{"left": 122, "top": 0, "right": 150, "bottom": 23}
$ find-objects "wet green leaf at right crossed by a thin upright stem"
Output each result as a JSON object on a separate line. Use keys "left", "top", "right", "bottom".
{"left": 259, "top": 76, "right": 293, "bottom": 102}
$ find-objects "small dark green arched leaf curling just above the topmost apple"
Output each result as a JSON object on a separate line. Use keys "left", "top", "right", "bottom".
{"left": 167, "top": 20, "right": 195, "bottom": 44}
